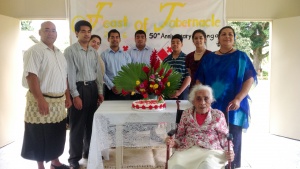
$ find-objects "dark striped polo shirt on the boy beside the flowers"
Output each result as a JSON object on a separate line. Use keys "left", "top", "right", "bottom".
{"left": 163, "top": 51, "right": 190, "bottom": 84}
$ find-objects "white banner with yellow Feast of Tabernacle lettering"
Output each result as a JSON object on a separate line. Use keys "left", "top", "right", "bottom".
{"left": 69, "top": 0, "right": 226, "bottom": 54}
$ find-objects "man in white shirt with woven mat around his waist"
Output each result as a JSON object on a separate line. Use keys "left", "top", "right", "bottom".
{"left": 21, "top": 21, "right": 72, "bottom": 169}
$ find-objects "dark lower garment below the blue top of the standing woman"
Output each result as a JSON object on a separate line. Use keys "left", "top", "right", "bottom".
{"left": 229, "top": 124, "right": 242, "bottom": 168}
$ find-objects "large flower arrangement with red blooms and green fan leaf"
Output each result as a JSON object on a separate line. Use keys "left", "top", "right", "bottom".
{"left": 114, "top": 50, "right": 181, "bottom": 101}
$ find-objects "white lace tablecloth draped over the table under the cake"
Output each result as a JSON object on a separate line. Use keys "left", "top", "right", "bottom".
{"left": 87, "top": 100, "right": 191, "bottom": 169}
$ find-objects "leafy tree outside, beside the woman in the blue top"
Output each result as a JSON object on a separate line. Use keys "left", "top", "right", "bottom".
{"left": 229, "top": 22, "right": 270, "bottom": 75}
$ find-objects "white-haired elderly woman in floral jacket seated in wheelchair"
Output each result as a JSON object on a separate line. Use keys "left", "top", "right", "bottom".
{"left": 166, "top": 85, "right": 234, "bottom": 169}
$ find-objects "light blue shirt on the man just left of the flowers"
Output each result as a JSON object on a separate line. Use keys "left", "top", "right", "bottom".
{"left": 101, "top": 48, "right": 131, "bottom": 89}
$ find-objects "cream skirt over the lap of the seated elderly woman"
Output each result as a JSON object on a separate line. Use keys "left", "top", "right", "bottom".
{"left": 168, "top": 146, "right": 227, "bottom": 169}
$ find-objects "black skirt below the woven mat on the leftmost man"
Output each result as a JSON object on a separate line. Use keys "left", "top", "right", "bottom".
{"left": 21, "top": 119, "right": 66, "bottom": 162}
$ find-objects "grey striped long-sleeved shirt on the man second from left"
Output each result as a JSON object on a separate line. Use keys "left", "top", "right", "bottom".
{"left": 64, "top": 42, "right": 103, "bottom": 97}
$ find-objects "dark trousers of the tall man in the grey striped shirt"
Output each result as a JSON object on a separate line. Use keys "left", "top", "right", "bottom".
{"left": 68, "top": 82, "right": 98, "bottom": 166}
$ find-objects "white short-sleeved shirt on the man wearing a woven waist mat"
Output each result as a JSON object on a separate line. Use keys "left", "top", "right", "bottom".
{"left": 22, "top": 42, "right": 67, "bottom": 94}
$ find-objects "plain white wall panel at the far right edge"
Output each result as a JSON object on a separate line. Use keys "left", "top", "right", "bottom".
{"left": 270, "top": 17, "right": 300, "bottom": 140}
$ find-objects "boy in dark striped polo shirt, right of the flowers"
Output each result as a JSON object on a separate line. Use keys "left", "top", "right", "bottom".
{"left": 163, "top": 34, "right": 191, "bottom": 100}
